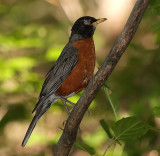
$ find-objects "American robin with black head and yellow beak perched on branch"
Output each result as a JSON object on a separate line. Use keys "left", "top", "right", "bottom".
{"left": 22, "top": 16, "right": 106, "bottom": 146}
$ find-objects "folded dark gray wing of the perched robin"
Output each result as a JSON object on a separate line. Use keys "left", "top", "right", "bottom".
{"left": 33, "top": 42, "right": 78, "bottom": 112}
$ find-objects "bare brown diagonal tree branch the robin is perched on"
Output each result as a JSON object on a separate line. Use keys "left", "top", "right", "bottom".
{"left": 54, "top": 0, "right": 150, "bottom": 156}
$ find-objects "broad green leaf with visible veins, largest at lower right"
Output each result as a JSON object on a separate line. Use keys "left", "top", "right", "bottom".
{"left": 113, "top": 117, "right": 149, "bottom": 141}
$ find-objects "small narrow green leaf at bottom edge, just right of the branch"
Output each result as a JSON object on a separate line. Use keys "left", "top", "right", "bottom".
{"left": 75, "top": 140, "right": 95, "bottom": 155}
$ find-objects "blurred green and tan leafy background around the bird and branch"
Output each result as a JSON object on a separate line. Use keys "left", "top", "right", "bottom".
{"left": 0, "top": 0, "right": 160, "bottom": 156}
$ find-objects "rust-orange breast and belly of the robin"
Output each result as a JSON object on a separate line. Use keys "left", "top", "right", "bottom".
{"left": 56, "top": 38, "right": 95, "bottom": 96}
